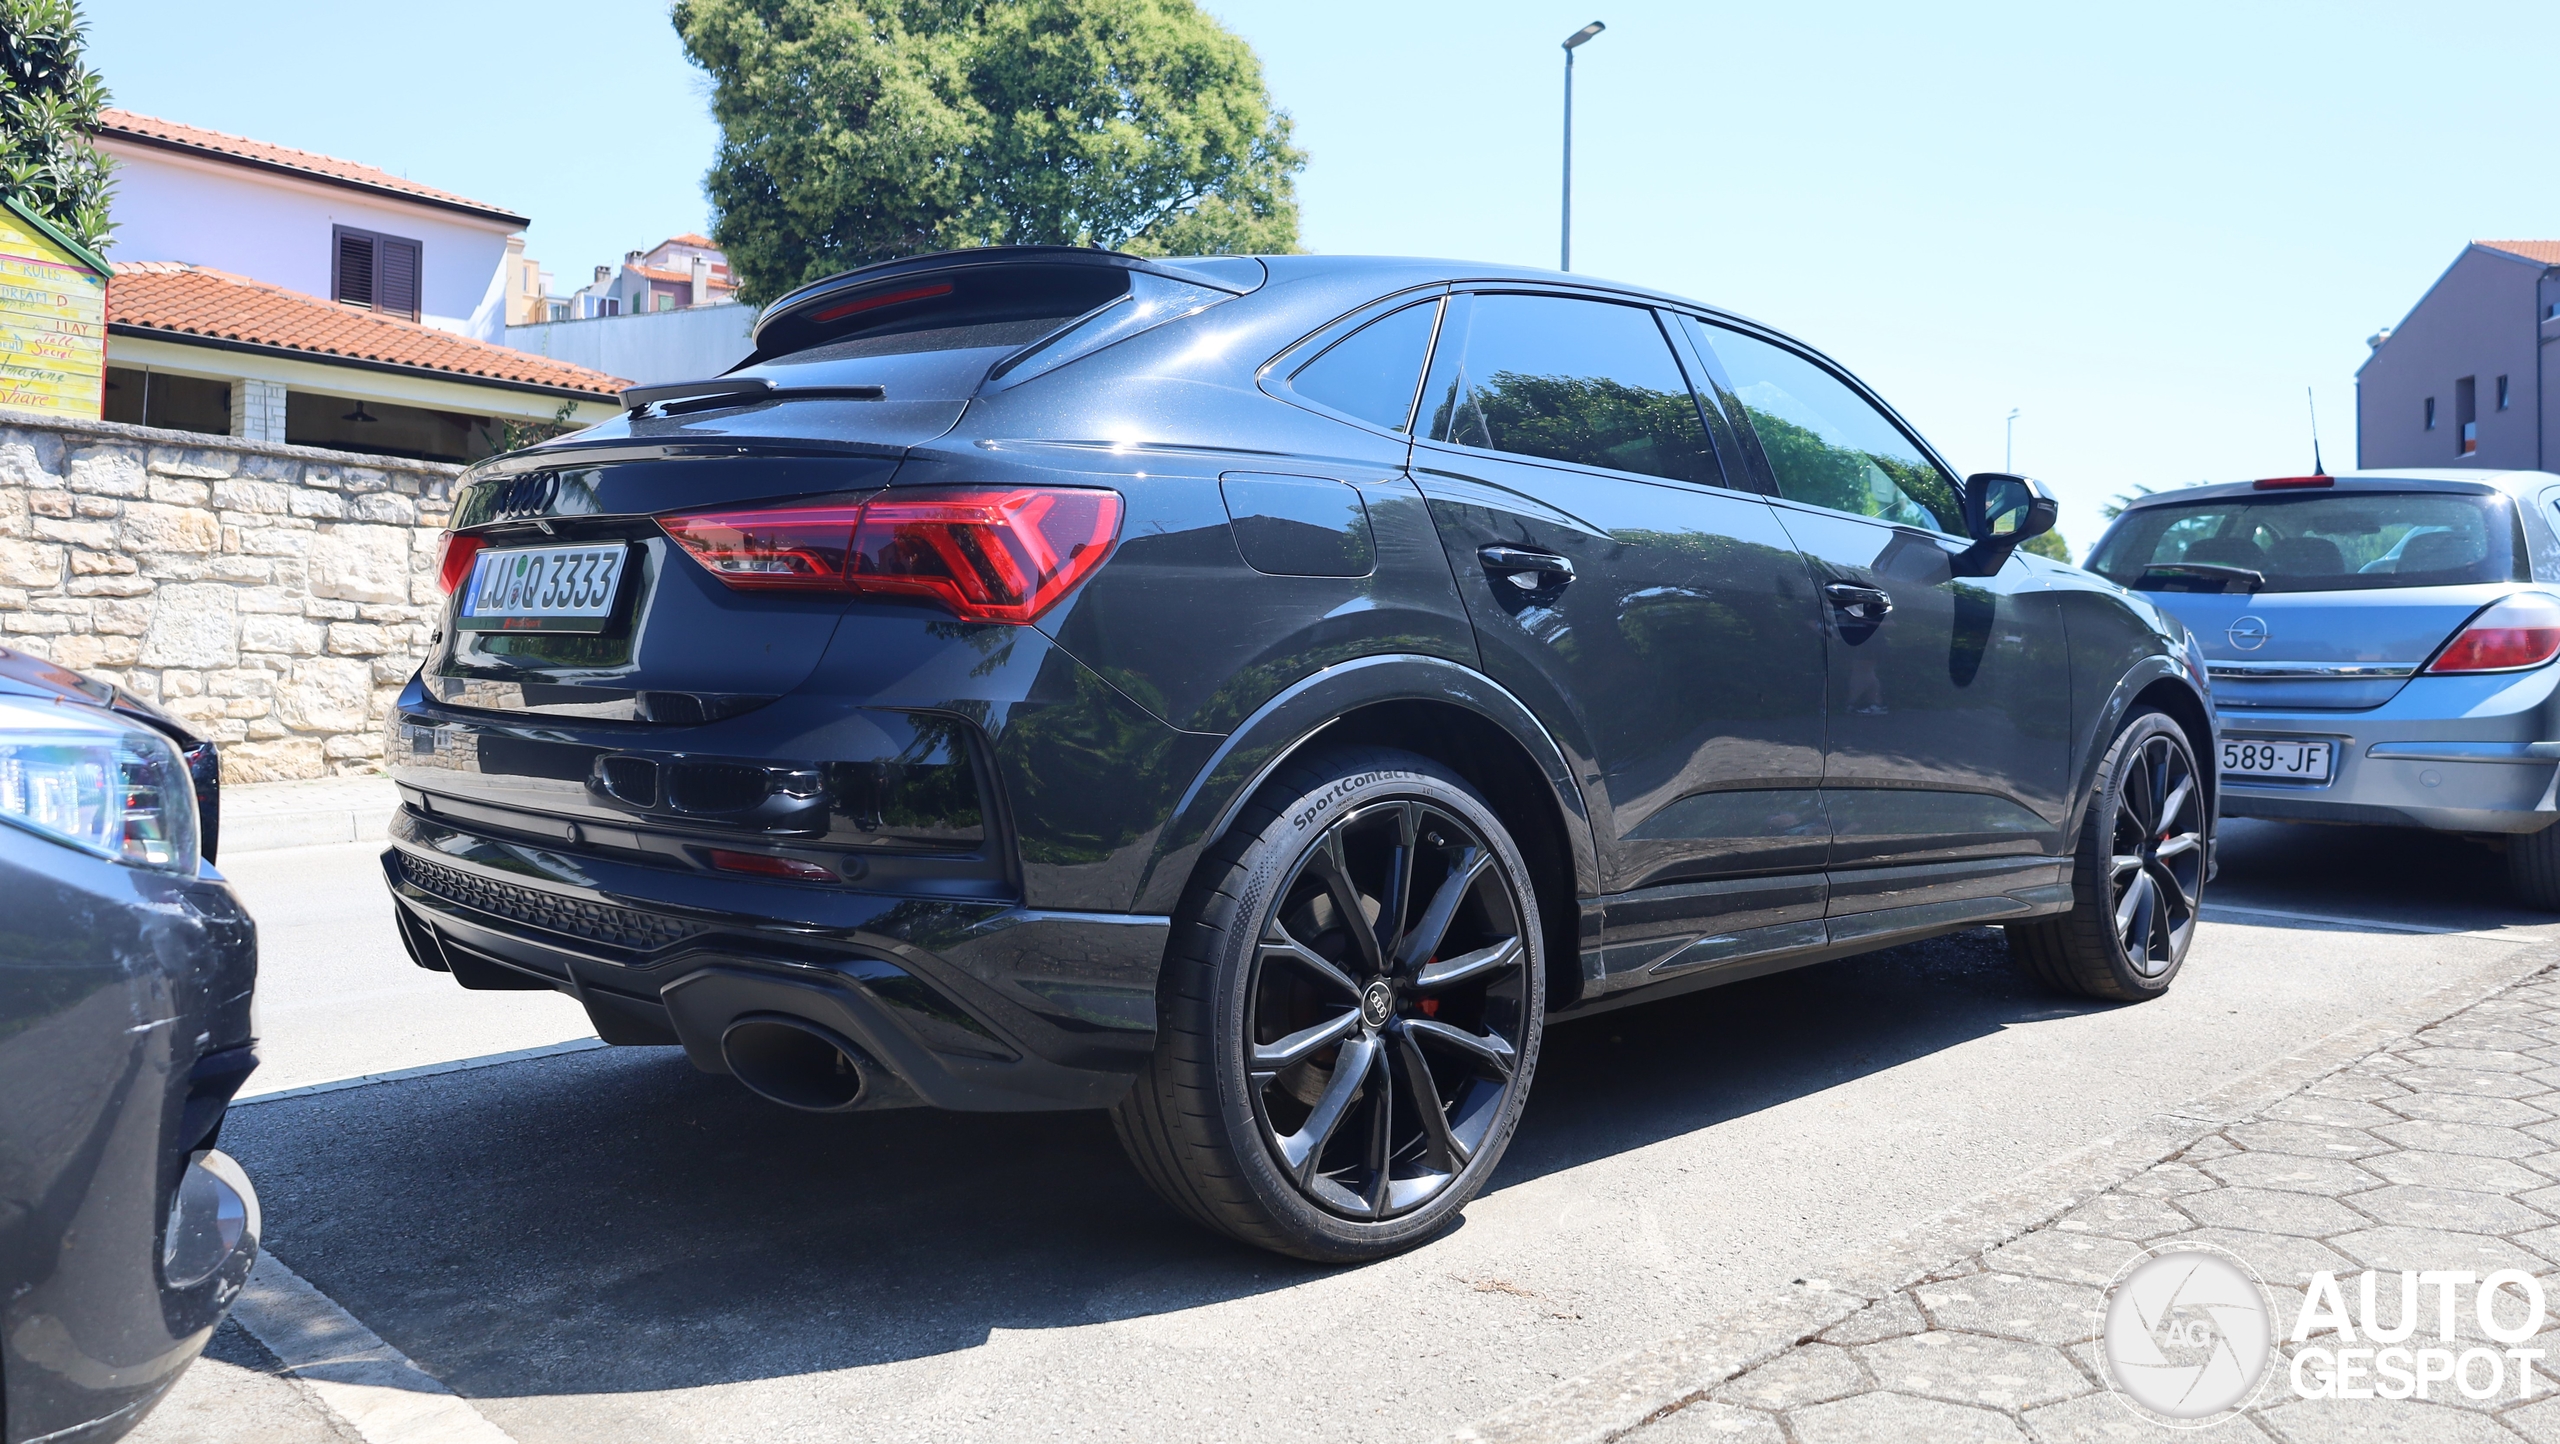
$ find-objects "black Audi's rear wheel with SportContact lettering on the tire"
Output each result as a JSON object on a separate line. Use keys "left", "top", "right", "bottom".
{"left": 1111, "top": 748, "right": 1546, "bottom": 1262}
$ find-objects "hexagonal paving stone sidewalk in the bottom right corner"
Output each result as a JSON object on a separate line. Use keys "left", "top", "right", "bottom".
{"left": 1623, "top": 973, "right": 2560, "bottom": 1444}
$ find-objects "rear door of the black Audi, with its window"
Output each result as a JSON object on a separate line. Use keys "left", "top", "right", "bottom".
{"left": 1413, "top": 292, "right": 1830, "bottom": 996}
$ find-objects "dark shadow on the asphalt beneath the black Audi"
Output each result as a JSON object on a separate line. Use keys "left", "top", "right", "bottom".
{"left": 209, "top": 929, "right": 2081, "bottom": 1398}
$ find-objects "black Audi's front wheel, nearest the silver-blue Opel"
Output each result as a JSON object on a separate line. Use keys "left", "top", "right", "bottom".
{"left": 2007, "top": 712, "right": 2212, "bottom": 1004}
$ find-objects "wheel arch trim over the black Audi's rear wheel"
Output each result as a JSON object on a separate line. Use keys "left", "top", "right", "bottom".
{"left": 1137, "top": 655, "right": 1600, "bottom": 1009}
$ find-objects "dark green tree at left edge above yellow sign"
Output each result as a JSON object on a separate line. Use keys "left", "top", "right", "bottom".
{"left": 0, "top": 0, "right": 115, "bottom": 251}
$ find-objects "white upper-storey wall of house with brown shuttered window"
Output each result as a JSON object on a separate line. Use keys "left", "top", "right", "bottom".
{"left": 100, "top": 138, "right": 524, "bottom": 346}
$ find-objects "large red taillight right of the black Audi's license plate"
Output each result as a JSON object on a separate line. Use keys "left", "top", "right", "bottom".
{"left": 658, "top": 486, "right": 1121, "bottom": 622}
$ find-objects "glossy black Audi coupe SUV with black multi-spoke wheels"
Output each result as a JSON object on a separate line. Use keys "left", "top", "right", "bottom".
{"left": 384, "top": 248, "right": 2214, "bottom": 1260}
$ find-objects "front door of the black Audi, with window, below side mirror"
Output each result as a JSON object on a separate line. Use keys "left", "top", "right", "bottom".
{"left": 1682, "top": 317, "right": 2071, "bottom": 942}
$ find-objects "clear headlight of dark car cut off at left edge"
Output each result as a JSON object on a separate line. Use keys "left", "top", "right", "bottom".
{"left": 0, "top": 696, "right": 197, "bottom": 878}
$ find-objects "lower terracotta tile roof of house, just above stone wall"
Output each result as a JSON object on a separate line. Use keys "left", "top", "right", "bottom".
{"left": 108, "top": 261, "right": 630, "bottom": 399}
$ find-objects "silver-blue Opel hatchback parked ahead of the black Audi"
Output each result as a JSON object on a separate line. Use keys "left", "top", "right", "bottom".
{"left": 2089, "top": 469, "right": 2560, "bottom": 911}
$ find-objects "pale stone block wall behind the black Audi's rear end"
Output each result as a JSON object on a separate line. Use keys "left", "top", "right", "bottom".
{"left": 0, "top": 420, "right": 461, "bottom": 781}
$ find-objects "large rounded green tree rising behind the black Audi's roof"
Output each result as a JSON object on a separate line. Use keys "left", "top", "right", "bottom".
{"left": 673, "top": 0, "right": 1306, "bottom": 302}
